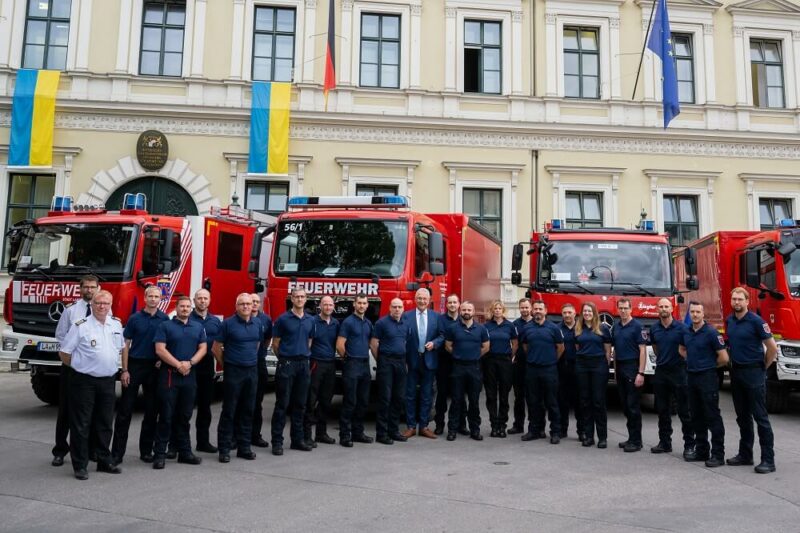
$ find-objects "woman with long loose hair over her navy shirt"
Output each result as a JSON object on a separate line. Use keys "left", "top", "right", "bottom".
{"left": 575, "top": 302, "right": 611, "bottom": 448}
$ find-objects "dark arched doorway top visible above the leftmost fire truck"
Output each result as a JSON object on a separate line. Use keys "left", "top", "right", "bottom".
{"left": 106, "top": 176, "right": 197, "bottom": 217}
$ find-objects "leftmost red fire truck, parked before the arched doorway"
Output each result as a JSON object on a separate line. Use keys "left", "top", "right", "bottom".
{"left": 0, "top": 194, "right": 275, "bottom": 404}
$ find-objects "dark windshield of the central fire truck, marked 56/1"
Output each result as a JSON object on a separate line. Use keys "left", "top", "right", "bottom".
{"left": 274, "top": 219, "right": 408, "bottom": 278}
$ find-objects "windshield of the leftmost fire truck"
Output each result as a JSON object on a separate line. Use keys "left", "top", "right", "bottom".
{"left": 16, "top": 224, "right": 136, "bottom": 279}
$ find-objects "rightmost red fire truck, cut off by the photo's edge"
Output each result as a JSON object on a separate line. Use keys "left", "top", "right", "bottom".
{"left": 675, "top": 220, "right": 800, "bottom": 413}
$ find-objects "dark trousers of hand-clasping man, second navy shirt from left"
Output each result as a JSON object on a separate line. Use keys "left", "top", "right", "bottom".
{"left": 155, "top": 365, "right": 197, "bottom": 457}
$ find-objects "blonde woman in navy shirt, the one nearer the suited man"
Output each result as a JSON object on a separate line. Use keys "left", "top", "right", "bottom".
{"left": 481, "top": 300, "right": 517, "bottom": 439}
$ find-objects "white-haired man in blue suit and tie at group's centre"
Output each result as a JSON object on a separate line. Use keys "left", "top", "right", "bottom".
{"left": 403, "top": 288, "right": 444, "bottom": 439}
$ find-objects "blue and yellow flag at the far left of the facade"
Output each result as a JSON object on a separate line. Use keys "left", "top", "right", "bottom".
{"left": 8, "top": 69, "right": 61, "bottom": 167}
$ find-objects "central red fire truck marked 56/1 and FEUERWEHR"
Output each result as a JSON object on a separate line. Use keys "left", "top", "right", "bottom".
{"left": 250, "top": 196, "right": 501, "bottom": 377}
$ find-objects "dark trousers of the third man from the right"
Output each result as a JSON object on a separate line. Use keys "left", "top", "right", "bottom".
{"left": 653, "top": 362, "right": 694, "bottom": 448}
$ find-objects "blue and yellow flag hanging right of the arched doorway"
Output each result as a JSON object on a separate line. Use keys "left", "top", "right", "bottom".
{"left": 247, "top": 82, "right": 292, "bottom": 174}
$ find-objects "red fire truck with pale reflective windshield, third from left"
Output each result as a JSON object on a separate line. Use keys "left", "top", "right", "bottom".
{"left": 511, "top": 220, "right": 679, "bottom": 386}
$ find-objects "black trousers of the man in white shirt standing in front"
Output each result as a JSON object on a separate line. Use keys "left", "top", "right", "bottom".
{"left": 69, "top": 369, "right": 116, "bottom": 470}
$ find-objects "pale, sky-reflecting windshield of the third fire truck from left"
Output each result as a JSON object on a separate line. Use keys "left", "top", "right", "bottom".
{"left": 539, "top": 241, "right": 672, "bottom": 295}
